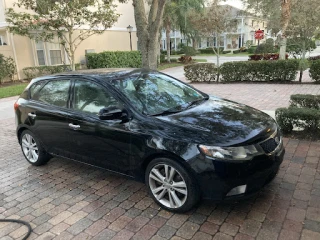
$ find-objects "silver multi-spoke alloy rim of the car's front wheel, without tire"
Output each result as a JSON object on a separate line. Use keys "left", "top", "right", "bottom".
{"left": 149, "top": 164, "right": 188, "bottom": 208}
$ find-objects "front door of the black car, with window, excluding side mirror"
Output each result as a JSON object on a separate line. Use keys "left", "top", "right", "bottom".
{"left": 68, "top": 78, "right": 131, "bottom": 175}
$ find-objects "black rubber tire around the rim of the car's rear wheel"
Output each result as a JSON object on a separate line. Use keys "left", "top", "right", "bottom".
{"left": 19, "top": 130, "right": 51, "bottom": 166}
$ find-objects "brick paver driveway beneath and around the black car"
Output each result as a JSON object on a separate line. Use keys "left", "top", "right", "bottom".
{"left": 0, "top": 84, "right": 320, "bottom": 240}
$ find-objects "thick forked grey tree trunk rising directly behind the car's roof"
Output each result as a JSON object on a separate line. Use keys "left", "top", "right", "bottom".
{"left": 133, "top": 0, "right": 166, "bottom": 70}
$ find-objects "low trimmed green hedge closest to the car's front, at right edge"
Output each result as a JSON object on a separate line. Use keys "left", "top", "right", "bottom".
{"left": 276, "top": 107, "right": 320, "bottom": 133}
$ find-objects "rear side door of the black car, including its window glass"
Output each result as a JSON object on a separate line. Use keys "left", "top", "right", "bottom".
{"left": 26, "top": 78, "right": 71, "bottom": 157}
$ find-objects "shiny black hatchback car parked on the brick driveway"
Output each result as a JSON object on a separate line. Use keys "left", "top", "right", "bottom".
{"left": 14, "top": 69, "right": 284, "bottom": 212}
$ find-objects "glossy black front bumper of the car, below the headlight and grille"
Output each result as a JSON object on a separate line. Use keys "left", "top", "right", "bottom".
{"left": 197, "top": 142, "right": 285, "bottom": 201}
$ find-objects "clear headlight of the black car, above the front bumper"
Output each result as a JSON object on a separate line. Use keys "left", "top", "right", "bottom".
{"left": 199, "top": 145, "right": 262, "bottom": 160}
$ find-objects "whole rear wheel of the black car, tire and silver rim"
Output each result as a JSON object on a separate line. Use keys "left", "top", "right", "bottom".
{"left": 20, "top": 130, "right": 50, "bottom": 166}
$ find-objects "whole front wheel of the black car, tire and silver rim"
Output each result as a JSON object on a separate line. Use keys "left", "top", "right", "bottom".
{"left": 145, "top": 158, "right": 199, "bottom": 213}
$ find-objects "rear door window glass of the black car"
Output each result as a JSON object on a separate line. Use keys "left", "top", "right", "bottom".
{"left": 32, "top": 80, "right": 70, "bottom": 107}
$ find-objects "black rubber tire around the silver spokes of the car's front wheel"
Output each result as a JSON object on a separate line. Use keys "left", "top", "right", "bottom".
{"left": 145, "top": 158, "right": 200, "bottom": 213}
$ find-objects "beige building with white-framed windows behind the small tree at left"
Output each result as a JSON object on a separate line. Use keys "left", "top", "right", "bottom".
{"left": 0, "top": 0, "right": 137, "bottom": 79}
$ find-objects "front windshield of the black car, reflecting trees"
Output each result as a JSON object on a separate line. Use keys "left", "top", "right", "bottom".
{"left": 111, "top": 73, "right": 207, "bottom": 115}
